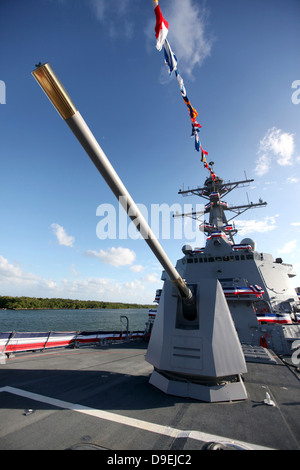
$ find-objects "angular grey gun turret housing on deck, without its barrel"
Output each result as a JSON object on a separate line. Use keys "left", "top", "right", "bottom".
{"left": 146, "top": 278, "right": 247, "bottom": 402}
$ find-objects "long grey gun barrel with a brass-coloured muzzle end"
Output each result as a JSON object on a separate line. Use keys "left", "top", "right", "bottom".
{"left": 32, "top": 63, "right": 193, "bottom": 302}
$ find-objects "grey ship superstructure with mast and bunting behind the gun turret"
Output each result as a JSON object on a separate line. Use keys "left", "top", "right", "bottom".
{"left": 169, "top": 173, "right": 300, "bottom": 354}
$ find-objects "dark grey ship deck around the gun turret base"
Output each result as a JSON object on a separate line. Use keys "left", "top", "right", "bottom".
{"left": 0, "top": 342, "right": 300, "bottom": 452}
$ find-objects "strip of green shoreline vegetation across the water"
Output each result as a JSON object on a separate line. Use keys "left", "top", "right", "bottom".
{"left": 0, "top": 296, "right": 153, "bottom": 310}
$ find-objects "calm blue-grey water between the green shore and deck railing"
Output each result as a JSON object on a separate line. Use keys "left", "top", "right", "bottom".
{"left": 0, "top": 309, "right": 148, "bottom": 332}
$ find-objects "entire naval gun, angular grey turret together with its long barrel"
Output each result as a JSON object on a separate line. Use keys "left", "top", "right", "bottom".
{"left": 32, "top": 63, "right": 247, "bottom": 402}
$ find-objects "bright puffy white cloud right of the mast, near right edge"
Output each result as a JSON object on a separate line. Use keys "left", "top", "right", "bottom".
{"left": 255, "top": 127, "right": 295, "bottom": 176}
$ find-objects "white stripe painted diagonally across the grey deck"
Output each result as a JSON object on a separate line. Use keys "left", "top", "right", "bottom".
{"left": 0, "top": 386, "right": 271, "bottom": 450}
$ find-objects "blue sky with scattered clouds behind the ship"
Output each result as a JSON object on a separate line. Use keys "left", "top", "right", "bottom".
{"left": 0, "top": 0, "right": 300, "bottom": 303}
